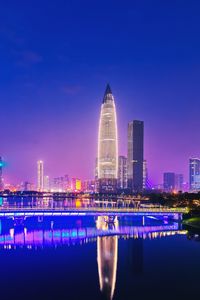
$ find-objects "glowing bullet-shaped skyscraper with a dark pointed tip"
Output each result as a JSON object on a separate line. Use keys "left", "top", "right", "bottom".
{"left": 97, "top": 85, "right": 118, "bottom": 192}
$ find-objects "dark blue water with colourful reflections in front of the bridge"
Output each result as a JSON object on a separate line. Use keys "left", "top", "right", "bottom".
{"left": 0, "top": 212, "right": 200, "bottom": 300}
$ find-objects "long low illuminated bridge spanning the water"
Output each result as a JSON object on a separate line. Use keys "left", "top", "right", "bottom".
{"left": 0, "top": 207, "right": 188, "bottom": 220}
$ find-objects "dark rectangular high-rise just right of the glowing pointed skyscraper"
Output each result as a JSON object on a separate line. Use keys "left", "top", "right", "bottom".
{"left": 127, "top": 120, "right": 144, "bottom": 192}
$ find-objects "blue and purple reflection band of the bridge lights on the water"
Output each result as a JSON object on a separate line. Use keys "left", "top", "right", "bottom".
{"left": 0, "top": 216, "right": 186, "bottom": 249}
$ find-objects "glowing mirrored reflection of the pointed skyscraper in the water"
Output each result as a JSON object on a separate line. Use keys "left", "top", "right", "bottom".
{"left": 97, "top": 217, "right": 118, "bottom": 300}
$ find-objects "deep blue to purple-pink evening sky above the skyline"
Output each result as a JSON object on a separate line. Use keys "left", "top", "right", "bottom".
{"left": 0, "top": 0, "right": 200, "bottom": 183}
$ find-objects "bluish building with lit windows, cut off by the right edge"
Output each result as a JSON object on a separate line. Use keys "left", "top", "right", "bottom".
{"left": 189, "top": 158, "right": 200, "bottom": 192}
